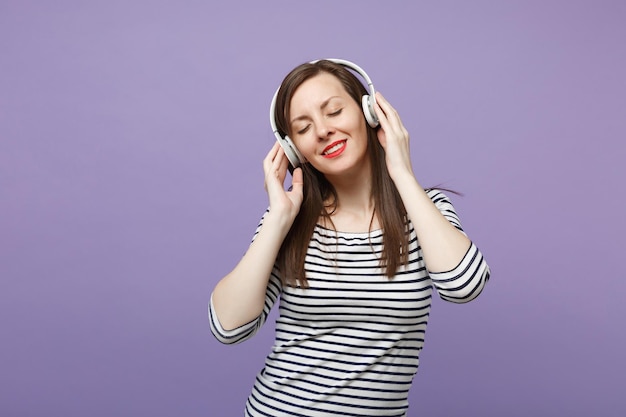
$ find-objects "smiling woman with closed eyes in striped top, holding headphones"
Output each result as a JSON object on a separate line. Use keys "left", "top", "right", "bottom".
{"left": 209, "top": 60, "right": 489, "bottom": 417}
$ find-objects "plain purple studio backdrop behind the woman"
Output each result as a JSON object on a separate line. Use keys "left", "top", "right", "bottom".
{"left": 0, "top": 0, "right": 626, "bottom": 417}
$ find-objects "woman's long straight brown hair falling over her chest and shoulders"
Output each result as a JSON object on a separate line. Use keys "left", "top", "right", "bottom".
{"left": 276, "top": 60, "right": 409, "bottom": 288}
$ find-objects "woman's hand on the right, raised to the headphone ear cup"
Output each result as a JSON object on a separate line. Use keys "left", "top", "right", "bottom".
{"left": 374, "top": 92, "right": 413, "bottom": 180}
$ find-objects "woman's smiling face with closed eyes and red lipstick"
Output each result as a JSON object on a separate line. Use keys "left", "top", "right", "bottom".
{"left": 289, "top": 72, "right": 368, "bottom": 177}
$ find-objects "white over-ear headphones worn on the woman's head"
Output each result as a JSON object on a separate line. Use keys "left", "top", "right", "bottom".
{"left": 270, "top": 58, "right": 378, "bottom": 168}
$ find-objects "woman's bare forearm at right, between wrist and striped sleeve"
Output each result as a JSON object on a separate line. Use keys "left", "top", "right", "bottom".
{"left": 394, "top": 172, "right": 471, "bottom": 272}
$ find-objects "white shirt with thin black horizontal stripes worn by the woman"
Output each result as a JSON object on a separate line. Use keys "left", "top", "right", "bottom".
{"left": 209, "top": 190, "right": 489, "bottom": 417}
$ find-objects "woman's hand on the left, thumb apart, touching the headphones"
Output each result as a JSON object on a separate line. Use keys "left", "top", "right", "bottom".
{"left": 263, "top": 142, "right": 303, "bottom": 223}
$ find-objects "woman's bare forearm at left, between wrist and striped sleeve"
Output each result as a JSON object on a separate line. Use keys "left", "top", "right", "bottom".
{"left": 212, "top": 212, "right": 290, "bottom": 330}
